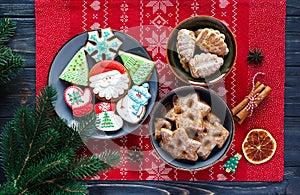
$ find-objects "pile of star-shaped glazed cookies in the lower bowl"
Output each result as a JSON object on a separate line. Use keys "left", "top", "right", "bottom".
{"left": 154, "top": 92, "right": 229, "bottom": 161}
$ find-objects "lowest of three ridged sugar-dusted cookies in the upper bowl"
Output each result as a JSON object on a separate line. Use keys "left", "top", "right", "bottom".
{"left": 189, "top": 53, "right": 224, "bottom": 78}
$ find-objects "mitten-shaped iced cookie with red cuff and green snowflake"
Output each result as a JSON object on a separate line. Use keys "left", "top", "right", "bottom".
{"left": 64, "top": 86, "right": 93, "bottom": 117}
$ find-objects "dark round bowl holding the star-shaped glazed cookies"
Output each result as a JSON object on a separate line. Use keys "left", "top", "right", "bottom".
{"left": 149, "top": 86, "right": 235, "bottom": 170}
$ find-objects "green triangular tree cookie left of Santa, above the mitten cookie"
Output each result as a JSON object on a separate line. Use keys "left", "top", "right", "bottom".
{"left": 59, "top": 48, "right": 89, "bottom": 86}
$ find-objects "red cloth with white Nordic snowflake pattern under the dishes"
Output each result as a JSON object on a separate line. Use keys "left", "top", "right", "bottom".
{"left": 35, "top": 0, "right": 285, "bottom": 181}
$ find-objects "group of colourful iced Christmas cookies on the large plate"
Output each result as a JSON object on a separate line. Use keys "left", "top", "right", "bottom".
{"left": 59, "top": 28, "right": 155, "bottom": 131}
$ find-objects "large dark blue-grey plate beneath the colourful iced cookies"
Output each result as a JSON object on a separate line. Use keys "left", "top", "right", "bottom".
{"left": 48, "top": 31, "right": 158, "bottom": 139}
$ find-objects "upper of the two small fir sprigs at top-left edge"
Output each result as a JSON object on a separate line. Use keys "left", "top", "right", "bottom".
{"left": 0, "top": 18, "right": 16, "bottom": 45}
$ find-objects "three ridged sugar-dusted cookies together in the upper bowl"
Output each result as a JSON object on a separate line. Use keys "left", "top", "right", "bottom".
{"left": 176, "top": 28, "right": 229, "bottom": 78}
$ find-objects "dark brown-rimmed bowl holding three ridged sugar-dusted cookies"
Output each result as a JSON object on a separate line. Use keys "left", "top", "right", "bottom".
{"left": 167, "top": 16, "right": 237, "bottom": 86}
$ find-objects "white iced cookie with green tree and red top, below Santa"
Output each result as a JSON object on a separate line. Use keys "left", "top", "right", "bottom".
{"left": 94, "top": 102, "right": 123, "bottom": 131}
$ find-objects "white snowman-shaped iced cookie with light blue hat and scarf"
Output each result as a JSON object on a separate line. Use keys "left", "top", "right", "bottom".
{"left": 117, "top": 83, "right": 151, "bottom": 124}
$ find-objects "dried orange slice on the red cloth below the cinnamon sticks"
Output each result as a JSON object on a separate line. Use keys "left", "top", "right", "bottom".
{"left": 242, "top": 129, "right": 277, "bottom": 164}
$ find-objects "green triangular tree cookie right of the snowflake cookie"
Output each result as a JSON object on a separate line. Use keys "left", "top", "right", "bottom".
{"left": 119, "top": 51, "right": 155, "bottom": 85}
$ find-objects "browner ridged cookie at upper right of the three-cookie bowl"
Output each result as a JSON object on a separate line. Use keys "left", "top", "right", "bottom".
{"left": 196, "top": 28, "right": 229, "bottom": 56}
